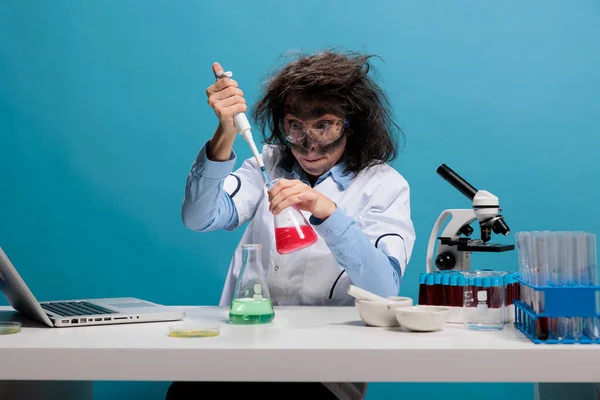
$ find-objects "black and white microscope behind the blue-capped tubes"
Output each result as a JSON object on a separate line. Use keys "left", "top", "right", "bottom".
{"left": 427, "top": 164, "right": 515, "bottom": 272}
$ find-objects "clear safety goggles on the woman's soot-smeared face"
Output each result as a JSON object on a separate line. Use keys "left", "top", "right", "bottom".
{"left": 280, "top": 118, "right": 350, "bottom": 147}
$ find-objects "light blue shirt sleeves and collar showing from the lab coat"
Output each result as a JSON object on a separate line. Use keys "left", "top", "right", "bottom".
{"left": 182, "top": 142, "right": 402, "bottom": 297}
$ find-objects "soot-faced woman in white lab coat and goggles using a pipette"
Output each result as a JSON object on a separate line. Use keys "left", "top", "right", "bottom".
{"left": 171, "top": 51, "right": 415, "bottom": 399}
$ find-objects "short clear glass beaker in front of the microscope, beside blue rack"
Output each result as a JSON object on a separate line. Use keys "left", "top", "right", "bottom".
{"left": 462, "top": 271, "right": 505, "bottom": 331}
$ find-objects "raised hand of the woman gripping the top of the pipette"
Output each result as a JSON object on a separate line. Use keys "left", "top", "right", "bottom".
{"left": 206, "top": 63, "right": 247, "bottom": 139}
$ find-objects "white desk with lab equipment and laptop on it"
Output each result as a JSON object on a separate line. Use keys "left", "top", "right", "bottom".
{"left": 0, "top": 307, "right": 600, "bottom": 382}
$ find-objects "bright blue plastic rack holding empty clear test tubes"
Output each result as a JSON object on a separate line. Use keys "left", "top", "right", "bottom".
{"left": 514, "top": 275, "right": 600, "bottom": 344}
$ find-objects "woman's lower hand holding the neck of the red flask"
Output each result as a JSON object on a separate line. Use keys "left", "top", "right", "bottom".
{"left": 269, "top": 179, "right": 336, "bottom": 220}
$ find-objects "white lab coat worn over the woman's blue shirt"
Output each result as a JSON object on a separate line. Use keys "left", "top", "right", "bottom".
{"left": 220, "top": 145, "right": 415, "bottom": 400}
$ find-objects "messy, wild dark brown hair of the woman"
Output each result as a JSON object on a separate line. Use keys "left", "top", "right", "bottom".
{"left": 252, "top": 50, "right": 402, "bottom": 173}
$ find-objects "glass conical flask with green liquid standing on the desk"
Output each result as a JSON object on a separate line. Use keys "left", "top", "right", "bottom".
{"left": 229, "top": 244, "right": 275, "bottom": 325}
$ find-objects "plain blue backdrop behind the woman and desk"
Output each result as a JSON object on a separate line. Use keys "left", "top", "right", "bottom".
{"left": 0, "top": 0, "right": 600, "bottom": 400}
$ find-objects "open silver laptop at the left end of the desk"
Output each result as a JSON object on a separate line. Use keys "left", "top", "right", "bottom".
{"left": 0, "top": 247, "right": 185, "bottom": 328}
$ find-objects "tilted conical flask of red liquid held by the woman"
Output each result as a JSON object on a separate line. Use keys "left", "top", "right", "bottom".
{"left": 274, "top": 206, "right": 318, "bottom": 254}
